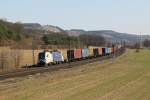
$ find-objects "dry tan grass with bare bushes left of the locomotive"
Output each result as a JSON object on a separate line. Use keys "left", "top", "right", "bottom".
{"left": 0, "top": 47, "right": 42, "bottom": 70}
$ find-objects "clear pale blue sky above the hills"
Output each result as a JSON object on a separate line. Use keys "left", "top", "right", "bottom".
{"left": 0, "top": 0, "right": 150, "bottom": 34}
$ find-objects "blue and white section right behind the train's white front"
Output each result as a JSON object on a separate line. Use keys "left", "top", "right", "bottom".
{"left": 52, "top": 51, "right": 64, "bottom": 63}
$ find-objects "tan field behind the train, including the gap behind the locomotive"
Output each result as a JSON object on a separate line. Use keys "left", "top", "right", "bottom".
{"left": 0, "top": 47, "right": 67, "bottom": 69}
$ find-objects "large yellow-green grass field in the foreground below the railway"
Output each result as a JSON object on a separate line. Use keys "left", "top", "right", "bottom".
{"left": 0, "top": 50, "right": 150, "bottom": 100}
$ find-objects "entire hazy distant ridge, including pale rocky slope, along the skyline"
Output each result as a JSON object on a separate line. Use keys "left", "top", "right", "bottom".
{"left": 24, "top": 23, "right": 149, "bottom": 45}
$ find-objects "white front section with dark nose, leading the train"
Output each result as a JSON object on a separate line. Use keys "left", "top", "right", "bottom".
{"left": 38, "top": 51, "right": 53, "bottom": 65}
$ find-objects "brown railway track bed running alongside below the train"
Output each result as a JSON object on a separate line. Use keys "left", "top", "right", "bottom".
{"left": 0, "top": 52, "right": 123, "bottom": 80}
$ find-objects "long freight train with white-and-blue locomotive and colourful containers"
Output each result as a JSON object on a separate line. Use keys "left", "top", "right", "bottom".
{"left": 38, "top": 45, "right": 124, "bottom": 65}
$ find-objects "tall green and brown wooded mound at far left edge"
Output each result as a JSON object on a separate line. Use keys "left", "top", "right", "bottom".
{"left": 0, "top": 20, "right": 26, "bottom": 45}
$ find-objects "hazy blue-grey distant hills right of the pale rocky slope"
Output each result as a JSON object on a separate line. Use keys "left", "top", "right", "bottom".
{"left": 67, "top": 29, "right": 149, "bottom": 45}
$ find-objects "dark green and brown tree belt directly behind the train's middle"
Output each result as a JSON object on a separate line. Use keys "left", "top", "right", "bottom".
{"left": 42, "top": 33, "right": 106, "bottom": 47}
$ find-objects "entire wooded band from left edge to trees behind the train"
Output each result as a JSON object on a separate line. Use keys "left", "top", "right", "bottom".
{"left": 0, "top": 20, "right": 105, "bottom": 48}
